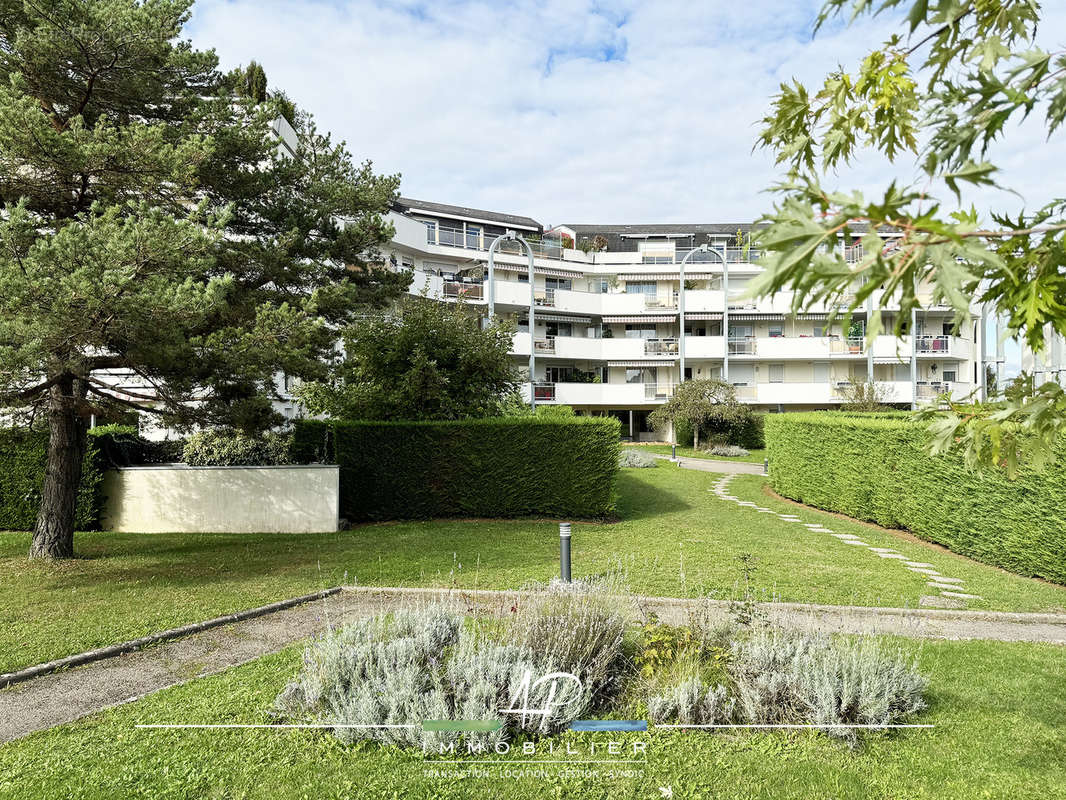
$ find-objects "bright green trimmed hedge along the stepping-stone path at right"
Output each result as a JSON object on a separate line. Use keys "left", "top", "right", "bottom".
{"left": 766, "top": 412, "right": 1066, "bottom": 583}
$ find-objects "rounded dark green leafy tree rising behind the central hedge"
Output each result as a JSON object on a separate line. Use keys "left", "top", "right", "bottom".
{"left": 297, "top": 297, "right": 518, "bottom": 419}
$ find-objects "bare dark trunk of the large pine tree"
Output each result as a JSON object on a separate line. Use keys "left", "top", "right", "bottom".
{"left": 30, "top": 378, "right": 88, "bottom": 559}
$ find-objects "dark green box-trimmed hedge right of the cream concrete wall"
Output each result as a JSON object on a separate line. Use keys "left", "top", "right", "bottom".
{"left": 293, "top": 417, "right": 619, "bottom": 521}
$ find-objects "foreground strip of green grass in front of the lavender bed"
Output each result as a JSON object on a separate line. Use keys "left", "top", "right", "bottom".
{"left": 0, "top": 641, "right": 1066, "bottom": 800}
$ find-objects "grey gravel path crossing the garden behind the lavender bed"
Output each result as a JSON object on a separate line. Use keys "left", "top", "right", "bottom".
{"left": 0, "top": 588, "right": 1066, "bottom": 742}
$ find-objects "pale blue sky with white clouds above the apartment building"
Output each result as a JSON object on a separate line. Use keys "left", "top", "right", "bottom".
{"left": 189, "top": 0, "right": 1066, "bottom": 223}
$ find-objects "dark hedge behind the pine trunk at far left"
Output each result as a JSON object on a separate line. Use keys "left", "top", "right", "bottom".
{"left": 0, "top": 429, "right": 107, "bottom": 530}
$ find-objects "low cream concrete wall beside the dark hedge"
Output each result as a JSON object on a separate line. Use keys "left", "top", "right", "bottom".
{"left": 101, "top": 464, "right": 340, "bottom": 533}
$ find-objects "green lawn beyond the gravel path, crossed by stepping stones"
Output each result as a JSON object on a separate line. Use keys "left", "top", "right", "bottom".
{"left": 0, "top": 464, "right": 1066, "bottom": 672}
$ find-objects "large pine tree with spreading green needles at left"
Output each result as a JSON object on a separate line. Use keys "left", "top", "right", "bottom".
{"left": 0, "top": 0, "right": 406, "bottom": 558}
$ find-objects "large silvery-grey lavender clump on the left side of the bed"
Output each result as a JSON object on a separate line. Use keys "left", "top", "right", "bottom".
{"left": 274, "top": 607, "right": 591, "bottom": 749}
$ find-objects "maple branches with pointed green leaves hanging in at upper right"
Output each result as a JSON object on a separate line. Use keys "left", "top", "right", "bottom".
{"left": 756, "top": 0, "right": 1066, "bottom": 468}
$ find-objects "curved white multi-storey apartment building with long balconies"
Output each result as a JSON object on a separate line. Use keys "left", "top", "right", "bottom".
{"left": 387, "top": 197, "right": 996, "bottom": 438}
